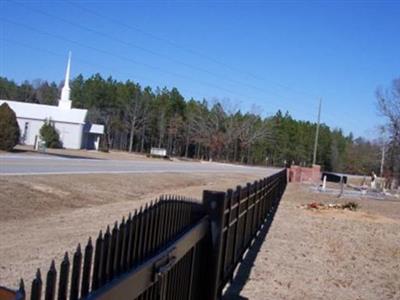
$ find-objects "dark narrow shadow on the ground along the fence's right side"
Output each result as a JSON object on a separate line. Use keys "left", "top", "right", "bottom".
{"left": 222, "top": 201, "right": 280, "bottom": 300}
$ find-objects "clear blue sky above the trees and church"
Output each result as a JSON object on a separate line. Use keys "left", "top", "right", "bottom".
{"left": 0, "top": 0, "right": 400, "bottom": 138}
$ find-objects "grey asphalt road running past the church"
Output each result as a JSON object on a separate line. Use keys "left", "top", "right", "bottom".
{"left": 0, "top": 154, "right": 278, "bottom": 176}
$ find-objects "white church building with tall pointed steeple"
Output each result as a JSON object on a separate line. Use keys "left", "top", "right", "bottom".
{"left": 0, "top": 53, "right": 104, "bottom": 150}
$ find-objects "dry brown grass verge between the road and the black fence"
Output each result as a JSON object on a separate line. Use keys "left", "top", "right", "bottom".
{"left": 0, "top": 172, "right": 265, "bottom": 287}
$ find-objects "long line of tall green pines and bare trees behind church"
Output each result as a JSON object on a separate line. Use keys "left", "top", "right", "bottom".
{"left": 0, "top": 74, "right": 381, "bottom": 174}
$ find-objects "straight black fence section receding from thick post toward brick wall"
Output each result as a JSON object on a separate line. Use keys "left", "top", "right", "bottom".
{"left": 203, "top": 170, "right": 287, "bottom": 299}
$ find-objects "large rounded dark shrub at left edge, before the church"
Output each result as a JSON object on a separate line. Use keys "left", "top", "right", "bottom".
{"left": 0, "top": 103, "right": 20, "bottom": 151}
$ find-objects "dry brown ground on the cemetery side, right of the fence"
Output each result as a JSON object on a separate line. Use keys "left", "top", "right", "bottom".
{"left": 227, "top": 184, "right": 400, "bottom": 299}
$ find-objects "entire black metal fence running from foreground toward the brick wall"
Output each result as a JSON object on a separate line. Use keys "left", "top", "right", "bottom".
{"left": 6, "top": 170, "right": 286, "bottom": 300}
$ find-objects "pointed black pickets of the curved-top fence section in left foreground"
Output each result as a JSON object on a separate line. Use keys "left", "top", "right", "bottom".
{"left": 15, "top": 195, "right": 205, "bottom": 299}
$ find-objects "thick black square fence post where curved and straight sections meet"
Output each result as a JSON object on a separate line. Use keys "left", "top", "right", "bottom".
{"left": 203, "top": 191, "right": 226, "bottom": 300}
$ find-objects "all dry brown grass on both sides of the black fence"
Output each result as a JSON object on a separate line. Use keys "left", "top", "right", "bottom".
{"left": 0, "top": 173, "right": 400, "bottom": 300}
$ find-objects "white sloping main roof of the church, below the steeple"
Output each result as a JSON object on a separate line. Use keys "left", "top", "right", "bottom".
{"left": 0, "top": 99, "right": 87, "bottom": 124}
